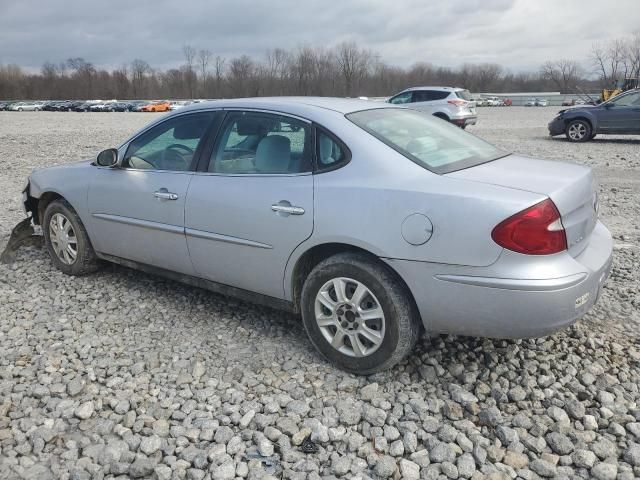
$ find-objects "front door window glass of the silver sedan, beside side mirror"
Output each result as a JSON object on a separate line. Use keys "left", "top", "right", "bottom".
{"left": 122, "top": 112, "right": 214, "bottom": 171}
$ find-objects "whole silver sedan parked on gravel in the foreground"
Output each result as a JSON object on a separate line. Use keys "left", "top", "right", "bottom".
{"left": 24, "top": 98, "right": 612, "bottom": 374}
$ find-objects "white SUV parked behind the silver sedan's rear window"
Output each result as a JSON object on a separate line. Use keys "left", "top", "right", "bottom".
{"left": 387, "top": 87, "right": 478, "bottom": 128}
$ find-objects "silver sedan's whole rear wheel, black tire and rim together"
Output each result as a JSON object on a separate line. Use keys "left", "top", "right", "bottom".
{"left": 300, "top": 253, "right": 421, "bottom": 375}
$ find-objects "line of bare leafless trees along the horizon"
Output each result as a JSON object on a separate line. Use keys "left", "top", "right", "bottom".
{"left": 0, "top": 31, "right": 640, "bottom": 100}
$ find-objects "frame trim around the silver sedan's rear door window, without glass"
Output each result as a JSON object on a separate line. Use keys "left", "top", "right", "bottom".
{"left": 201, "top": 107, "right": 316, "bottom": 177}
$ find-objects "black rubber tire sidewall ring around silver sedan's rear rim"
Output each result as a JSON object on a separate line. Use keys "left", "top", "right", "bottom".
{"left": 301, "top": 256, "right": 410, "bottom": 374}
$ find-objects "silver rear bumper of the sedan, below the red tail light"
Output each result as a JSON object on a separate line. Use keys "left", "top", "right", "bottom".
{"left": 386, "top": 222, "right": 613, "bottom": 338}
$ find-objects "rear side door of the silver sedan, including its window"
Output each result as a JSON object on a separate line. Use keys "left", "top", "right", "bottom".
{"left": 185, "top": 112, "right": 313, "bottom": 298}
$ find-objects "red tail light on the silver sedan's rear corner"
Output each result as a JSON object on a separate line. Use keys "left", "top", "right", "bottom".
{"left": 491, "top": 198, "right": 567, "bottom": 255}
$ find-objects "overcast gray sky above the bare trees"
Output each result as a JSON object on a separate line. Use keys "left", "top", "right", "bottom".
{"left": 0, "top": 0, "right": 640, "bottom": 71}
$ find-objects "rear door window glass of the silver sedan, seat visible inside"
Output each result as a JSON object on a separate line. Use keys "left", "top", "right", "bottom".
{"left": 209, "top": 112, "right": 313, "bottom": 174}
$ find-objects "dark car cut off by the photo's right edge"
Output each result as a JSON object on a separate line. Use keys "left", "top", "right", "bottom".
{"left": 548, "top": 89, "right": 640, "bottom": 142}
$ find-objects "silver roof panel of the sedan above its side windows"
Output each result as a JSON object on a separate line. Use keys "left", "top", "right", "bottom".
{"left": 180, "top": 97, "right": 389, "bottom": 115}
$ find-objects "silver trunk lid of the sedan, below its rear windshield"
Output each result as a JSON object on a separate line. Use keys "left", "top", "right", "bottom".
{"left": 447, "top": 155, "right": 598, "bottom": 257}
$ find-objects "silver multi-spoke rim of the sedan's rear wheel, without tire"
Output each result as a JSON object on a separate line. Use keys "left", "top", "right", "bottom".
{"left": 315, "top": 277, "right": 385, "bottom": 357}
